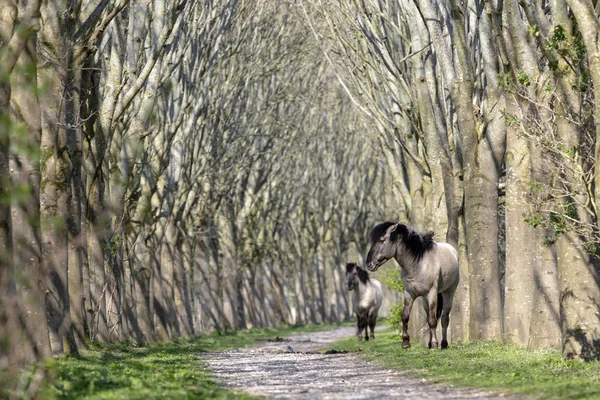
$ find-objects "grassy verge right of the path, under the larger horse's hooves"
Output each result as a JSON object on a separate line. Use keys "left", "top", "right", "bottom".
{"left": 332, "top": 330, "right": 600, "bottom": 399}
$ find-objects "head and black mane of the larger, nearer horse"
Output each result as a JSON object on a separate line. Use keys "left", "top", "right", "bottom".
{"left": 367, "top": 221, "right": 435, "bottom": 271}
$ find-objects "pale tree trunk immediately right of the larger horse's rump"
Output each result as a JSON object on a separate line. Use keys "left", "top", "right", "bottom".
{"left": 421, "top": 1, "right": 502, "bottom": 339}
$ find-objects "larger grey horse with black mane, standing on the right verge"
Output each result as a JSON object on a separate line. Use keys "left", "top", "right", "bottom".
{"left": 366, "top": 221, "right": 459, "bottom": 349}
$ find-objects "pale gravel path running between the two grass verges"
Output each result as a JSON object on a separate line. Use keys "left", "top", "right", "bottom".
{"left": 202, "top": 328, "right": 520, "bottom": 400}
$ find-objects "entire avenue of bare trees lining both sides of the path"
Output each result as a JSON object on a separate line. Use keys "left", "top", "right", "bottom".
{"left": 0, "top": 0, "right": 600, "bottom": 393}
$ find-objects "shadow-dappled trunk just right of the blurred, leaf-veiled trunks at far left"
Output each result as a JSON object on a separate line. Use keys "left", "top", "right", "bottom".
{"left": 38, "top": 3, "right": 77, "bottom": 353}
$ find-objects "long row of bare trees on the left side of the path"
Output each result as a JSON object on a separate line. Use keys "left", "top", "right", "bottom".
{"left": 0, "top": 0, "right": 396, "bottom": 394}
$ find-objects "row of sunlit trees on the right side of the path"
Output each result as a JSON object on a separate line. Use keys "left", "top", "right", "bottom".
{"left": 302, "top": 0, "right": 600, "bottom": 360}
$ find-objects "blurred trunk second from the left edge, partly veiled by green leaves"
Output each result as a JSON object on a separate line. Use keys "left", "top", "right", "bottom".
{"left": 10, "top": 32, "right": 50, "bottom": 361}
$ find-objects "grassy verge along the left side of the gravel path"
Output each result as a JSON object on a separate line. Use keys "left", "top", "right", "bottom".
{"left": 30, "top": 324, "right": 350, "bottom": 400}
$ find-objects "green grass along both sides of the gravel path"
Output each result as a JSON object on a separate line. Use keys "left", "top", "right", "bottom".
{"left": 21, "top": 322, "right": 600, "bottom": 400}
